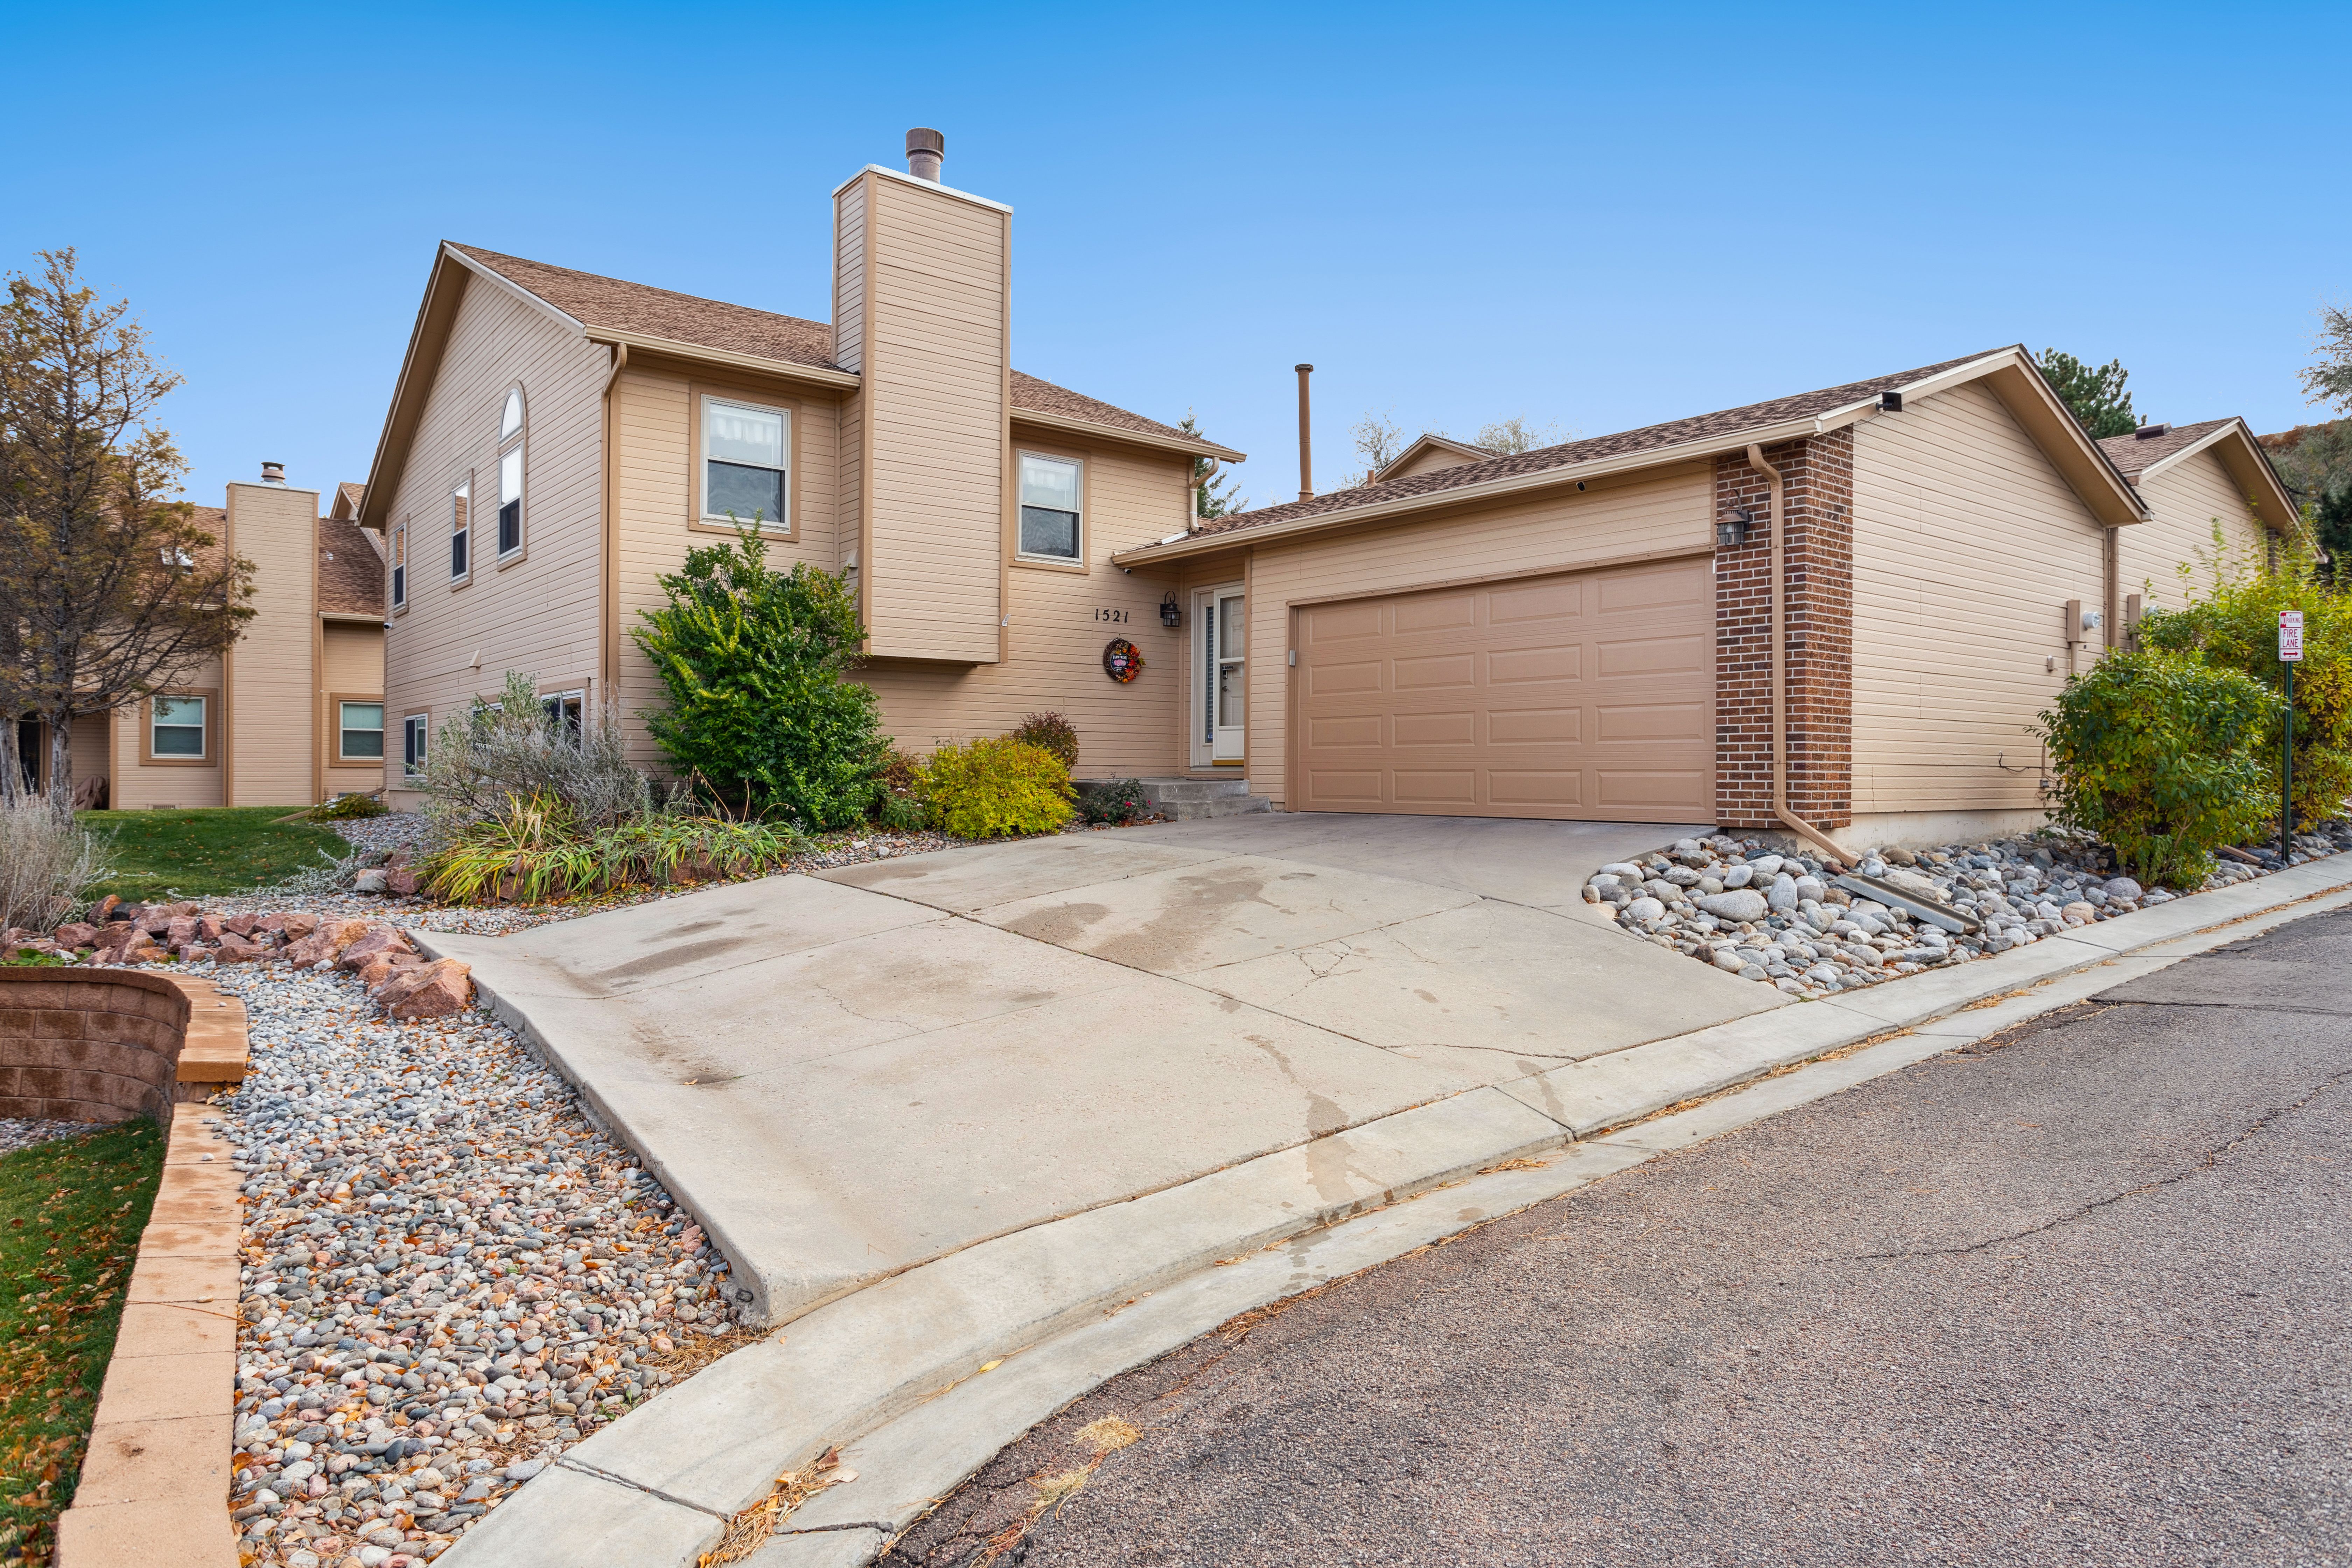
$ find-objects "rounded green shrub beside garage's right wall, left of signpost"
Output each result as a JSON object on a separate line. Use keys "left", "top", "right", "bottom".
{"left": 2042, "top": 651, "right": 2284, "bottom": 886}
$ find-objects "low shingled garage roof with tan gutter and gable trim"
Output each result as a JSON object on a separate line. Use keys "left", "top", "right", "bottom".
{"left": 1113, "top": 343, "right": 2147, "bottom": 567}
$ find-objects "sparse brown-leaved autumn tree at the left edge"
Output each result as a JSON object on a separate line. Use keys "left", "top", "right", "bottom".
{"left": 0, "top": 249, "right": 254, "bottom": 811}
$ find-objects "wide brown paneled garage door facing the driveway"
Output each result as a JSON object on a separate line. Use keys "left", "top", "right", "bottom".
{"left": 1294, "top": 557, "right": 1715, "bottom": 823}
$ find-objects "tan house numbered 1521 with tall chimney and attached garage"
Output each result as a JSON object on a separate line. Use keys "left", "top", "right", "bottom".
{"left": 360, "top": 132, "right": 2296, "bottom": 842}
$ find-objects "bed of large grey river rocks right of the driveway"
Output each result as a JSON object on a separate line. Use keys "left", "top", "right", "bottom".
{"left": 1585, "top": 823, "right": 2352, "bottom": 999}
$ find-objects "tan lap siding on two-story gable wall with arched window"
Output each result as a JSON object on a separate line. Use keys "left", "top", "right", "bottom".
{"left": 383, "top": 278, "right": 611, "bottom": 804}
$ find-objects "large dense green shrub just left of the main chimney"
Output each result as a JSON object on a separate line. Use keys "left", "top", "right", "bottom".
{"left": 630, "top": 529, "right": 889, "bottom": 830}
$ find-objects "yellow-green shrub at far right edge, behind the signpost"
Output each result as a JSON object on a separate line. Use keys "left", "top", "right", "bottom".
{"left": 2140, "top": 538, "right": 2352, "bottom": 823}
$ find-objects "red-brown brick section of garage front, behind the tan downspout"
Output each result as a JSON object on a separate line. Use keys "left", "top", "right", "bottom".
{"left": 1715, "top": 430, "right": 1853, "bottom": 827}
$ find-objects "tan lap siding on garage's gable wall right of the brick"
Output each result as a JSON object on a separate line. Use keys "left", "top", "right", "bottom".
{"left": 1853, "top": 383, "right": 2105, "bottom": 813}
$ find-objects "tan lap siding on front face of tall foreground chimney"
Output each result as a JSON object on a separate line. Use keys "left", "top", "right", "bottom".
{"left": 856, "top": 176, "right": 1007, "bottom": 663}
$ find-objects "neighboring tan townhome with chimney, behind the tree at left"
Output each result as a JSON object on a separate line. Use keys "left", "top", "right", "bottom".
{"left": 19, "top": 463, "right": 383, "bottom": 811}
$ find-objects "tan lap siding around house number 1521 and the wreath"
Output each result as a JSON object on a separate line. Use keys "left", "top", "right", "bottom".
{"left": 859, "top": 428, "right": 1190, "bottom": 778}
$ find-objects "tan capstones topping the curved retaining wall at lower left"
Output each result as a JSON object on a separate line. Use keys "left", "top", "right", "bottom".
{"left": 30, "top": 971, "right": 247, "bottom": 1568}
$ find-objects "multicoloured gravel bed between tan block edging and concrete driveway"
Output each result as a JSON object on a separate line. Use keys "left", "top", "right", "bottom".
{"left": 210, "top": 959, "right": 752, "bottom": 1568}
